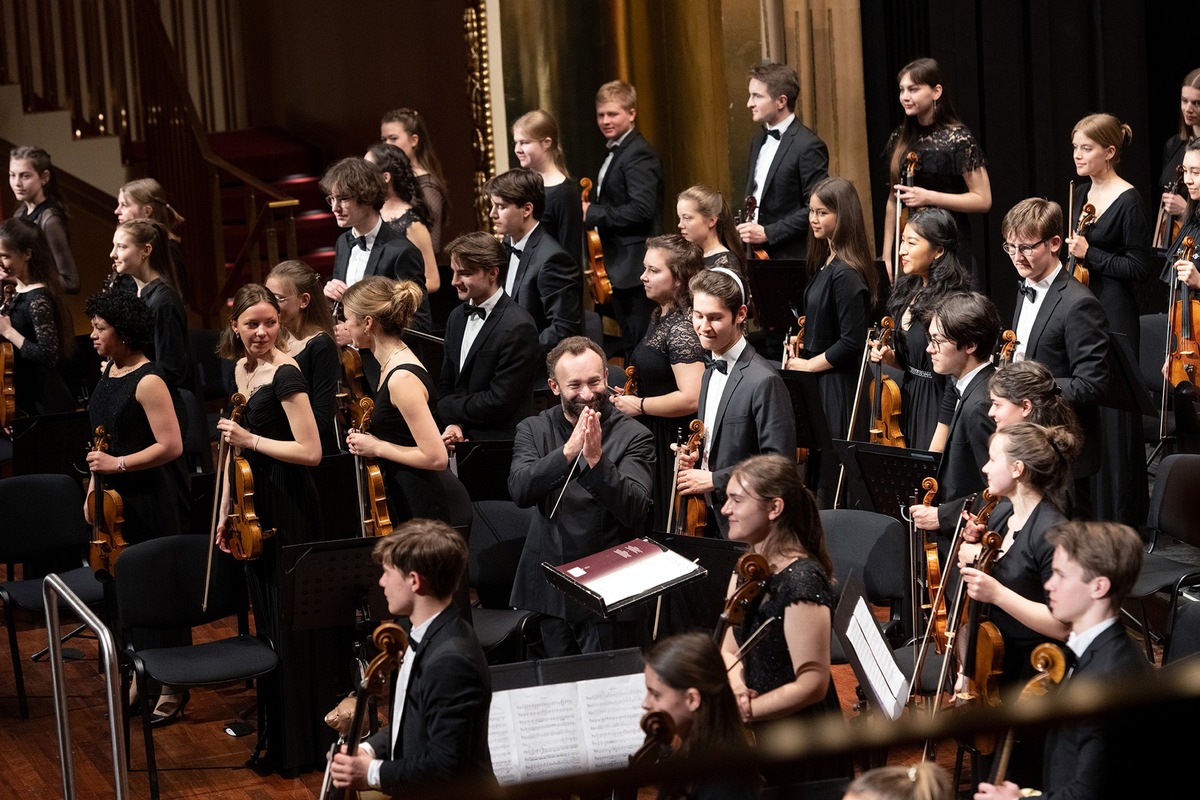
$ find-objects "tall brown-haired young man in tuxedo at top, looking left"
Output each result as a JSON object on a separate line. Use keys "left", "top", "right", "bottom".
{"left": 738, "top": 64, "right": 829, "bottom": 258}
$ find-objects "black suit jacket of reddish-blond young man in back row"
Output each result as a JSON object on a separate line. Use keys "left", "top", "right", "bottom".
{"left": 583, "top": 128, "right": 662, "bottom": 289}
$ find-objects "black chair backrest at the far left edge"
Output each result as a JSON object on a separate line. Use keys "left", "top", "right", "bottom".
{"left": 0, "top": 475, "right": 89, "bottom": 567}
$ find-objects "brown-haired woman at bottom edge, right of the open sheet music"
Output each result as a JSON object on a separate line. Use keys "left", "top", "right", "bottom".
{"left": 642, "top": 633, "right": 758, "bottom": 800}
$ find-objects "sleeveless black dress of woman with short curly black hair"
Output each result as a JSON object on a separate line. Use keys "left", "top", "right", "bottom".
{"left": 88, "top": 362, "right": 188, "bottom": 545}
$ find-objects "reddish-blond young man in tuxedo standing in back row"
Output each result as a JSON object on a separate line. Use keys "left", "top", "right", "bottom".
{"left": 583, "top": 80, "right": 662, "bottom": 360}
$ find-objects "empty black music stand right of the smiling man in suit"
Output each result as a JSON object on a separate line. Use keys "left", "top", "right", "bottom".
{"left": 833, "top": 439, "right": 942, "bottom": 524}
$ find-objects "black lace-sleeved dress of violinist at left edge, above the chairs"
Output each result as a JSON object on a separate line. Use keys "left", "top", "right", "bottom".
{"left": 8, "top": 287, "right": 76, "bottom": 416}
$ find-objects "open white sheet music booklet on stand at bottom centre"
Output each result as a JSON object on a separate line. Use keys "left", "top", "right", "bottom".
{"left": 487, "top": 673, "right": 646, "bottom": 786}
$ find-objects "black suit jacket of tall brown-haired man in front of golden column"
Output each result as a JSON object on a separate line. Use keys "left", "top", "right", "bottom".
{"left": 746, "top": 118, "right": 829, "bottom": 258}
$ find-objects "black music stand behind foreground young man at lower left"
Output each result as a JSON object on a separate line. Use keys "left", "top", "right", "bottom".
{"left": 278, "top": 537, "right": 391, "bottom": 631}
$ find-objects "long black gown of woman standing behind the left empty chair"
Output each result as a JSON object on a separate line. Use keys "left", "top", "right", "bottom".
{"left": 230, "top": 363, "right": 328, "bottom": 774}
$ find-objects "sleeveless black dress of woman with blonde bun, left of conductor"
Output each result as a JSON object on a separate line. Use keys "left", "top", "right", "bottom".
{"left": 371, "top": 363, "right": 449, "bottom": 525}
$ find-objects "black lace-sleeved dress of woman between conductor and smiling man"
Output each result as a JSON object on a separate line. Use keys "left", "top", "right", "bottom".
{"left": 630, "top": 308, "right": 704, "bottom": 530}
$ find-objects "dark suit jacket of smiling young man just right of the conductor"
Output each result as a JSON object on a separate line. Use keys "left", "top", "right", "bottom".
{"left": 696, "top": 344, "right": 796, "bottom": 536}
